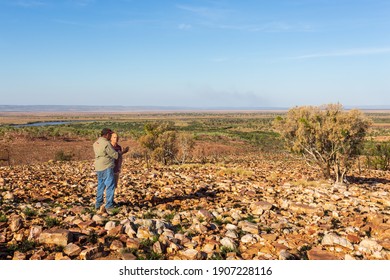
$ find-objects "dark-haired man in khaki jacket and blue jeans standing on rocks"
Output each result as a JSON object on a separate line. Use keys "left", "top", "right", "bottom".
{"left": 93, "top": 128, "right": 121, "bottom": 214}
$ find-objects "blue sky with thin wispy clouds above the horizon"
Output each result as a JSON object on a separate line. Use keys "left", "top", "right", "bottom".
{"left": 0, "top": 0, "right": 390, "bottom": 107}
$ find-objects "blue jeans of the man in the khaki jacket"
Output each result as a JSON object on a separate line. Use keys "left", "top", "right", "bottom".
{"left": 95, "top": 168, "right": 115, "bottom": 209}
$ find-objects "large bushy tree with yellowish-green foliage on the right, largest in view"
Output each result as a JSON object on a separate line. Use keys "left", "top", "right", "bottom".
{"left": 273, "top": 104, "right": 371, "bottom": 183}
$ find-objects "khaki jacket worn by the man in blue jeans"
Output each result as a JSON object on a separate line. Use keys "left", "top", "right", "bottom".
{"left": 93, "top": 137, "right": 119, "bottom": 171}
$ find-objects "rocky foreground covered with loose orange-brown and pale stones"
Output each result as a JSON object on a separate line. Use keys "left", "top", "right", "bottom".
{"left": 0, "top": 149, "right": 390, "bottom": 260}
